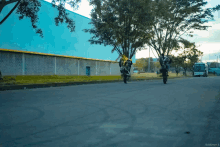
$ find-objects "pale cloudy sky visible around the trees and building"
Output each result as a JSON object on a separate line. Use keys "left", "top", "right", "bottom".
{"left": 46, "top": 0, "right": 220, "bottom": 62}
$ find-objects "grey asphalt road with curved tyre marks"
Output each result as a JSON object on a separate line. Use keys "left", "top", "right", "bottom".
{"left": 0, "top": 77, "right": 220, "bottom": 147}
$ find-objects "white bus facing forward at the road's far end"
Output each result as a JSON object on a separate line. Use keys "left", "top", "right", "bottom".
{"left": 193, "top": 62, "right": 208, "bottom": 77}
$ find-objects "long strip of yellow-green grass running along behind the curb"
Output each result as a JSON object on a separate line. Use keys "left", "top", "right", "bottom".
{"left": 1, "top": 73, "right": 187, "bottom": 85}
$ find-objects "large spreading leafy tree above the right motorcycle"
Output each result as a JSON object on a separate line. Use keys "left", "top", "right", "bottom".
{"left": 146, "top": 0, "right": 220, "bottom": 66}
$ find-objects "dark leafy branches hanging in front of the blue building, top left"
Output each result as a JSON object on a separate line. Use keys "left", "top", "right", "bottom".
{"left": 0, "top": 0, "right": 81, "bottom": 38}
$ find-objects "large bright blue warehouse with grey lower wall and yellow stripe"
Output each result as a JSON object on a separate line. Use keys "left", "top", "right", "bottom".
{"left": 0, "top": 0, "right": 135, "bottom": 75}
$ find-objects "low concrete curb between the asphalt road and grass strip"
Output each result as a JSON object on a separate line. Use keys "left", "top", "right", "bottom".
{"left": 0, "top": 77, "right": 189, "bottom": 91}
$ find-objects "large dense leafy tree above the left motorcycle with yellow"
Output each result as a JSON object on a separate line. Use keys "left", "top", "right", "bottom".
{"left": 84, "top": 0, "right": 153, "bottom": 60}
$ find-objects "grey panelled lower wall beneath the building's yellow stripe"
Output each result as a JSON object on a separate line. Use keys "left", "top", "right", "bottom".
{"left": 0, "top": 51, "right": 133, "bottom": 76}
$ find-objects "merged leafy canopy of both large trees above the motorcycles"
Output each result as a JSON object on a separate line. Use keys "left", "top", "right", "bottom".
{"left": 84, "top": 0, "right": 220, "bottom": 62}
